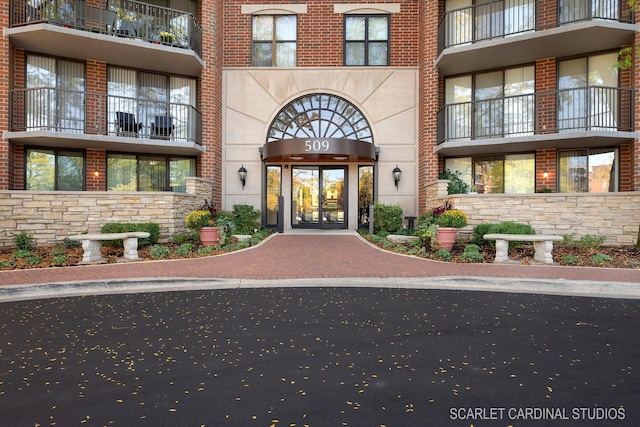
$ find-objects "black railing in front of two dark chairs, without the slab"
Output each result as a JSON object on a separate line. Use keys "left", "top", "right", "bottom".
{"left": 9, "top": 87, "right": 202, "bottom": 145}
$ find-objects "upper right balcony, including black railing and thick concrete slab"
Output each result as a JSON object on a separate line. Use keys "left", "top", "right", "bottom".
{"left": 436, "top": 0, "right": 638, "bottom": 75}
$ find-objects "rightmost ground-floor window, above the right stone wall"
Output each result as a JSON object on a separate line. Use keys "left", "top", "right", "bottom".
{"left": 558, "top": 148, "right": 619, "bottom": 193}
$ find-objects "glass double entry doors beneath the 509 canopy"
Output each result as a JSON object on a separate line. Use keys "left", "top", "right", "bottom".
{"left": 291, "top": 166, "right": 347, "bottom": 228}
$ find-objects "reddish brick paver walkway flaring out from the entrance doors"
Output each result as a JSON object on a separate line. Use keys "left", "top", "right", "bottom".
{"left": 0, "top": 234, "right": 640, "bottom": 285}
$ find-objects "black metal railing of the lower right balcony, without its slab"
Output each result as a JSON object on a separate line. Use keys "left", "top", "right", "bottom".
{"left": 437, "top": 86, "right": 633, "bottom": 144}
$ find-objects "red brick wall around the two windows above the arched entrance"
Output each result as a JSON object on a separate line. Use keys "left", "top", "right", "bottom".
{"left": 223, "top": 0, "right": 420, "bottom": 67}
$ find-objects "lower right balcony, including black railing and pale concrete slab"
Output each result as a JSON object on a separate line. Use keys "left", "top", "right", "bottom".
{"left": 437, "top": 86, "right": 636, "bottom": 155}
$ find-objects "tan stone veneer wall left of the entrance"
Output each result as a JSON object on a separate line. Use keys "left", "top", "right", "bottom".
{"left": 0, "top": 178, "right": 212, "bottom": 247}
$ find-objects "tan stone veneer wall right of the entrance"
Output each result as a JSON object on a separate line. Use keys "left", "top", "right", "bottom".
{"left": 426, "top": 180, "right": 640, "bottom": 245}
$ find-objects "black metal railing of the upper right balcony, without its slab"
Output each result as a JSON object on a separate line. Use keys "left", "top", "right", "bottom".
{"left": 438, "top": 0, "right": 633, "bottom": 53}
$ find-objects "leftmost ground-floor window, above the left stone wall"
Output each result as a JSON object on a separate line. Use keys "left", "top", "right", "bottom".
{"left": 25, "top": 148, "right": 85, "bottom": 191}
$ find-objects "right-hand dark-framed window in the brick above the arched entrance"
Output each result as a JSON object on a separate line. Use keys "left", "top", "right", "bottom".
{"left": 344, "top": 15, "right": 389, "bottom": 65}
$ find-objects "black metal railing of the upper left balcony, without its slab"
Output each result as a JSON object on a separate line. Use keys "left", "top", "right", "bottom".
{"left": 10, "top": 0, "right": 202, "bottom": 56}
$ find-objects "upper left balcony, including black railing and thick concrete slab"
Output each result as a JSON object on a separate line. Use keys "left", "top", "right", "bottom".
{"left": 4, "top": 0, "right": 204, "bottom": 75}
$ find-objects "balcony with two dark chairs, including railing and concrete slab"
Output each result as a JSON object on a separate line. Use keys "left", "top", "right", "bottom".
{"left": 4, "top": 88, "right": 203, "bottom": 155}
